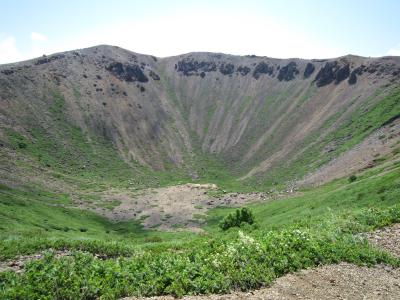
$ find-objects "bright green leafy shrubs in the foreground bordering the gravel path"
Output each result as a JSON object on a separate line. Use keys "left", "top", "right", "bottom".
{"left": 0, "top": 206, "right": 400, "bottom": 299}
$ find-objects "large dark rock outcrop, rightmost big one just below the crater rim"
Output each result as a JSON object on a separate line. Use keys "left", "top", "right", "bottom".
{"left": 315, "top": 61, "right": 350, "bottom": 87}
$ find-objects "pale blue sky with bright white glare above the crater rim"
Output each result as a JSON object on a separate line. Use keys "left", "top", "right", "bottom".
{"left": 0, "top": 0, "right": 400, "bottom": 63}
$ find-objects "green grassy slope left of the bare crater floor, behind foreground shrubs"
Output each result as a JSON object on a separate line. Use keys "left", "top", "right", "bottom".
{"left": 0, "top": 180, "right": 197, "bottom": 259}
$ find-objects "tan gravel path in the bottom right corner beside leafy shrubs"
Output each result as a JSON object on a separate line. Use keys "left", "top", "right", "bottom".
{"left": 126, "top": 224, "right": 400, "bottom": 300}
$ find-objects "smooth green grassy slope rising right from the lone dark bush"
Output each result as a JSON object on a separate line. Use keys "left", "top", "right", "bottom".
{"left": 207, "top": 160, "right": 400, "bottom": 231}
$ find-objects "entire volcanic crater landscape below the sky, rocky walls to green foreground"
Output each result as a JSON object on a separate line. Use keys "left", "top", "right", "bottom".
{"left": 0, "top": 45, "right": 400, "bottom": 299}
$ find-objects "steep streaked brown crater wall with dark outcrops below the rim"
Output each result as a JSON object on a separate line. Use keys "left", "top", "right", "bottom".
{"left": 0, "top": 46, "right": 400, "bottom": 185}
